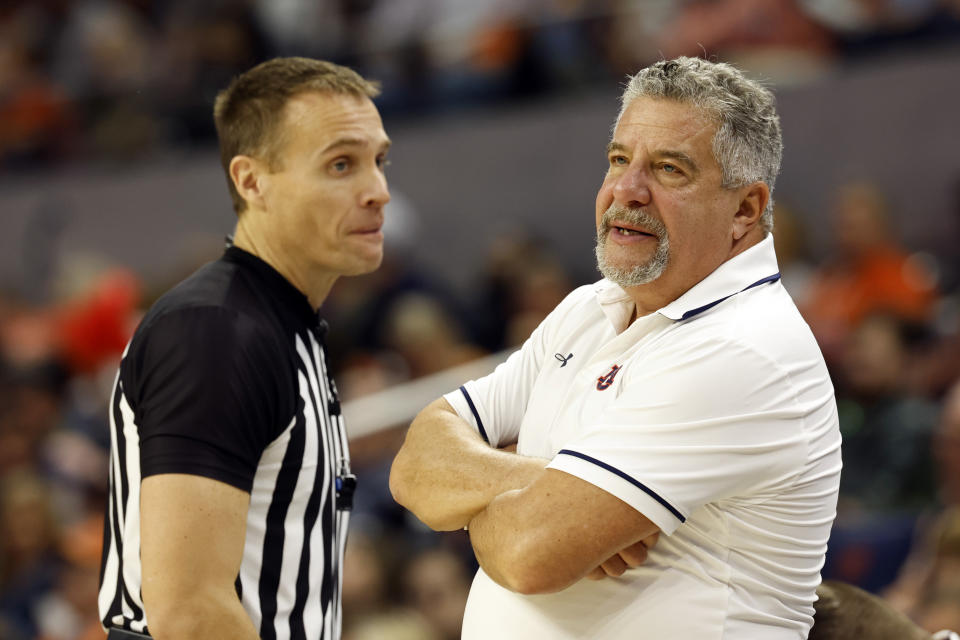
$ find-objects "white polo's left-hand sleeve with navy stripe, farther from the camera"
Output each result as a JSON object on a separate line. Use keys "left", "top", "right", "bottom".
{"left": 444, "top": 287, "right": 588, "bottom": 447}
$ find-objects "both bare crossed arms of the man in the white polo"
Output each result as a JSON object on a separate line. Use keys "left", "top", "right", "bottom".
{"left": 390, "top": 399, "right": 659, "bottom": 593}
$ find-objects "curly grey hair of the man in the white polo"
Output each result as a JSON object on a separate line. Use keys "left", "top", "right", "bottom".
{"left": 617, "top": 57, "right": 783, "bottom": 234}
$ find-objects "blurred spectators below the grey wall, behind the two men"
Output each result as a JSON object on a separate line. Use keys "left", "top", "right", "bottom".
{"left": 0, "top": 172, "right": 960, "bottom": 640}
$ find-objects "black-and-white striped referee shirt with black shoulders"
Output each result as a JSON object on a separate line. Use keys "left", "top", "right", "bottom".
{"left": 99, "top": 247, "right": 353, "bottom": 640}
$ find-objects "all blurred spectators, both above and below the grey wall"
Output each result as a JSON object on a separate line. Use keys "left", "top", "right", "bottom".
{"left": 0, "top": 0, "right": 960, "bottom": 640}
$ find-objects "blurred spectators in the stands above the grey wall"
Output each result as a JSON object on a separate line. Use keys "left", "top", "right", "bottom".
{"left": 0, "top": 0, "right": 960, "bottom": 169}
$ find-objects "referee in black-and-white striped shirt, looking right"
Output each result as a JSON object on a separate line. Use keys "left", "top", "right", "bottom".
{"left": 99, "top": 58, "right": 390, "bottom": 640}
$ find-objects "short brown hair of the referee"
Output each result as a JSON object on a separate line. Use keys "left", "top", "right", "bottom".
{"left": 213, "top": 58, "right": 380, "bottom": 214}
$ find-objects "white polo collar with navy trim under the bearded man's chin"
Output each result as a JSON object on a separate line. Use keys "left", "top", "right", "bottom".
{"left": 594, "top": 233, "right": 780, "bottom": 327}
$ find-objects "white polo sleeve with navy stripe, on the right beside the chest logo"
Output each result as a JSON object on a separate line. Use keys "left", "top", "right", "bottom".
{"left": 548, "top": 340, "right": 809, "bottom": 535}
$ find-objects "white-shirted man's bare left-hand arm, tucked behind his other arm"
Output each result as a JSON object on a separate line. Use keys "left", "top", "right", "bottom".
{"left": 390, "top": 398, "right": 547, "bottom": 531}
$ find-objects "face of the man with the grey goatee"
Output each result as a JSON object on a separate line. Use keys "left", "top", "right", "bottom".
{"left": 596, "top": 98, "right": 766, "bottom": 313}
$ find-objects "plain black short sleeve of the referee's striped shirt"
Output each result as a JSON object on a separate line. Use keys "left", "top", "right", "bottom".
{"left": 124, "top": 307, "right": 293, "bottom": 492}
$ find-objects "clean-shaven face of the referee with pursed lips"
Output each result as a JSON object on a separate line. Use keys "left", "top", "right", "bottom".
{"left": 262, "top": 93, "right": 390, "bottom": 281}
